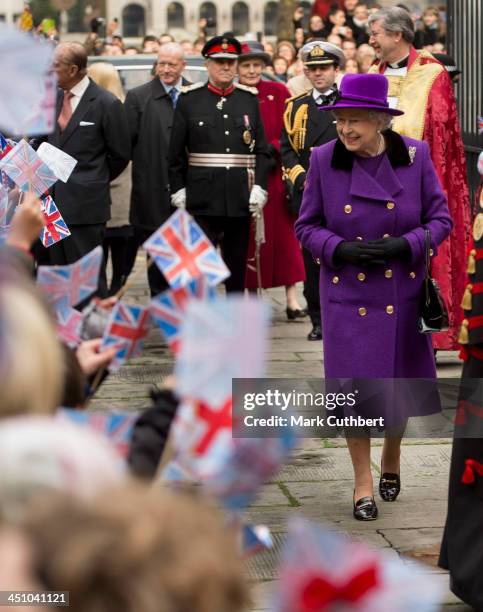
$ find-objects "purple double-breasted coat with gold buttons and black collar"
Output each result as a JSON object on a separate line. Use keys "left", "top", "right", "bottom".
{"left": 295, "top": 131, "right": 452, "bottom": 378}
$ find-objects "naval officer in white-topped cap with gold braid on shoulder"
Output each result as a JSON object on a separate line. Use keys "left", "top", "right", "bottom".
{"left": 281, "top": 40, "right": 345, "bottom": 340}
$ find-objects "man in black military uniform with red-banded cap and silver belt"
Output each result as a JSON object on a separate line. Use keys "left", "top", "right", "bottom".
{"left": 169, "top": 36, "right": 270, "bottom": 292}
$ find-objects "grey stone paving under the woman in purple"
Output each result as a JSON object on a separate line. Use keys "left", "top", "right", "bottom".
{"left": 91, "top": 256, "right": 469, "bottom": 612}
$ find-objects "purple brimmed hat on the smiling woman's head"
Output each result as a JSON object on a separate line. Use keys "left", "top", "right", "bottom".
{"left": 319, "top": 74, "right": 404, "bottom": 115}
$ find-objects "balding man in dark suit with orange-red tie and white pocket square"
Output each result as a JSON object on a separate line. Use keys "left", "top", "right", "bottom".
{"left": 41, "top": 43, "right": 130, "bottom": 294}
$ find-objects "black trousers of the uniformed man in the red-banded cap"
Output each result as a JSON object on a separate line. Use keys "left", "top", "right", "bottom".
{"left": 195, "top": 216, "right": 251, "bottom": 293}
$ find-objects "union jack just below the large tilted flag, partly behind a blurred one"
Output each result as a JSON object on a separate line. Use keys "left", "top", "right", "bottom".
{"left": 149, "top": 276, "right": 216, "bottom": 353}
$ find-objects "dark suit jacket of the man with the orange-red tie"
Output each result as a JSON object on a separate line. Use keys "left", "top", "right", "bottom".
{"left": 47, "top": 81, "right": 130, "bottom": 225}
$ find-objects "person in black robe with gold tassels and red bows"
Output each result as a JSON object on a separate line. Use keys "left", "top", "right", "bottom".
{"left": 439, "top": 153, "right": 483, "bottom": 610}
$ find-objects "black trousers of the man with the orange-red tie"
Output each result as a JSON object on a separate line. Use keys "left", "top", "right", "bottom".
{"left": 34, "top": 223, "right": 107, "bottom": 298}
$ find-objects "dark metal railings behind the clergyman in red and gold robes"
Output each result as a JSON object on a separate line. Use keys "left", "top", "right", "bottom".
{"left": 447, "top": 0, "right": 483, "bottom": 202}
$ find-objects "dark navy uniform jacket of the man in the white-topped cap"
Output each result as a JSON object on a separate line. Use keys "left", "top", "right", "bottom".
{"left": 280, "top": 90, "right": 337, "bottom": 213}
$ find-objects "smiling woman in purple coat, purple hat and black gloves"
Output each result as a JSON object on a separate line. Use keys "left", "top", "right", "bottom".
{"left": 295, "top": 74, "right": 452, "bottom": 520}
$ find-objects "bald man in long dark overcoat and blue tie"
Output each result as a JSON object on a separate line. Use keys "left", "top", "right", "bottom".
{"left": 124, "top": 43, "right": 188, "bottom": 295}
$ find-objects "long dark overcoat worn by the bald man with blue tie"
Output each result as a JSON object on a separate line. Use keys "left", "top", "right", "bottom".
{"left": 124, "top": 77, "right": 189, "bottom": 231}
